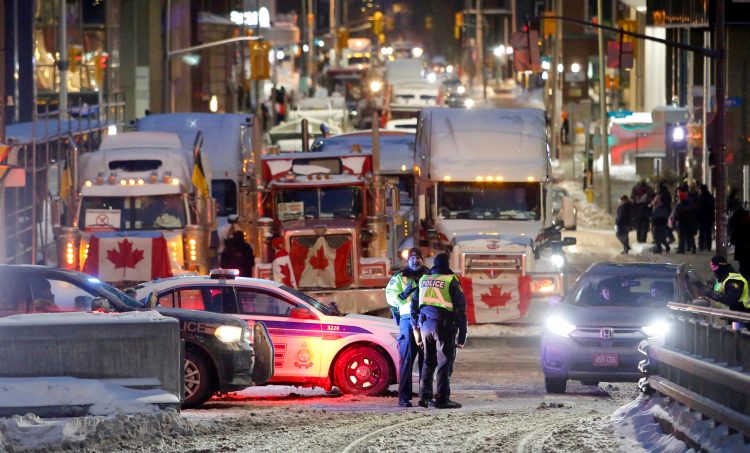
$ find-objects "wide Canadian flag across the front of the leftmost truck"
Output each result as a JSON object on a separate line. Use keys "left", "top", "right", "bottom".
{"left": 83, "top": 232, "right": 172, "bottom": 282}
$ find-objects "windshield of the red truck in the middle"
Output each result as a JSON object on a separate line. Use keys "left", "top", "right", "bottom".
{"left": 276, "top": 187, "right": 362, "bottom": 221}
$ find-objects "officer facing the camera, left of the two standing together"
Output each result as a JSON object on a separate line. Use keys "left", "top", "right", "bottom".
{"left": 385, "top": 247, "right": 429, "bottom": 407}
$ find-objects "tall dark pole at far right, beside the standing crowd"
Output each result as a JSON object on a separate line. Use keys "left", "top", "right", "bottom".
{"left": 716, "top": 0, "right": 727, "bottom": 256}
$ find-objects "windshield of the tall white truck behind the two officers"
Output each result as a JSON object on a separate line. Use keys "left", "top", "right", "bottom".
{"left": 438, "top": 182, "right": 541, "bottom": 220}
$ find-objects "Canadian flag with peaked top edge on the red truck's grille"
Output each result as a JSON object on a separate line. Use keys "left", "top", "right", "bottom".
{"left": 290, "top": 236, "right": 352, "bottom": 288}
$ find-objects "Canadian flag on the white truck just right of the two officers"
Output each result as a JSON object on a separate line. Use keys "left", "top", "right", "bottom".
{"left": 460, "top": 274, "right": 531, "bottom": 324}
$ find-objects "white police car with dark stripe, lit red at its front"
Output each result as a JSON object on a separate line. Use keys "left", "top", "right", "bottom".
{"left": 135, "top": 269, "right": 406, "bottom": 395}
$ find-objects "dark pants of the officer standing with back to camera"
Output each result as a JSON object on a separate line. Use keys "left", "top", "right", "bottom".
{"left": 419, "top": 318, "right": 456, "bottom": 404}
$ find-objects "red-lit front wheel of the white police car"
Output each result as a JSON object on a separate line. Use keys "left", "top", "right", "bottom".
{"left": 333, "top": 346, "right": 391, "bottom": 396}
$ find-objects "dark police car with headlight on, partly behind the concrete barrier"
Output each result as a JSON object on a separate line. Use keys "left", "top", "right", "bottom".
{"left": 0, "top": 265, "right": 274, "bottom": 408}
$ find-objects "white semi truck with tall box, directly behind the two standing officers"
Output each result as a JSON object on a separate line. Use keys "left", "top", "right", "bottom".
{"left": 415, "top": 108, "right": 575, "bottom": 323}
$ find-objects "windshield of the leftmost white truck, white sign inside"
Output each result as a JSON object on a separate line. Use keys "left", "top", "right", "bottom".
{"left": 78, "top": 194, "right": 187, "bottom": 231}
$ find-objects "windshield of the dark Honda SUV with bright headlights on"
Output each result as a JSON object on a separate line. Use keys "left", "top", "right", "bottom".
{"left": 565, "top": 274, "right": 677, "bottom": 307}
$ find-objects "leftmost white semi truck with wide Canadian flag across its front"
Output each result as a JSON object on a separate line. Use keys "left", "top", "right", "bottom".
{"left": 55, "top": 132, "right": 216, "bottom": 286}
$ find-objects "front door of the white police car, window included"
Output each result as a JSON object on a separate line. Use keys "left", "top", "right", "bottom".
{"left": 235, "top": 286, "right": 322, "bottom": 382}
